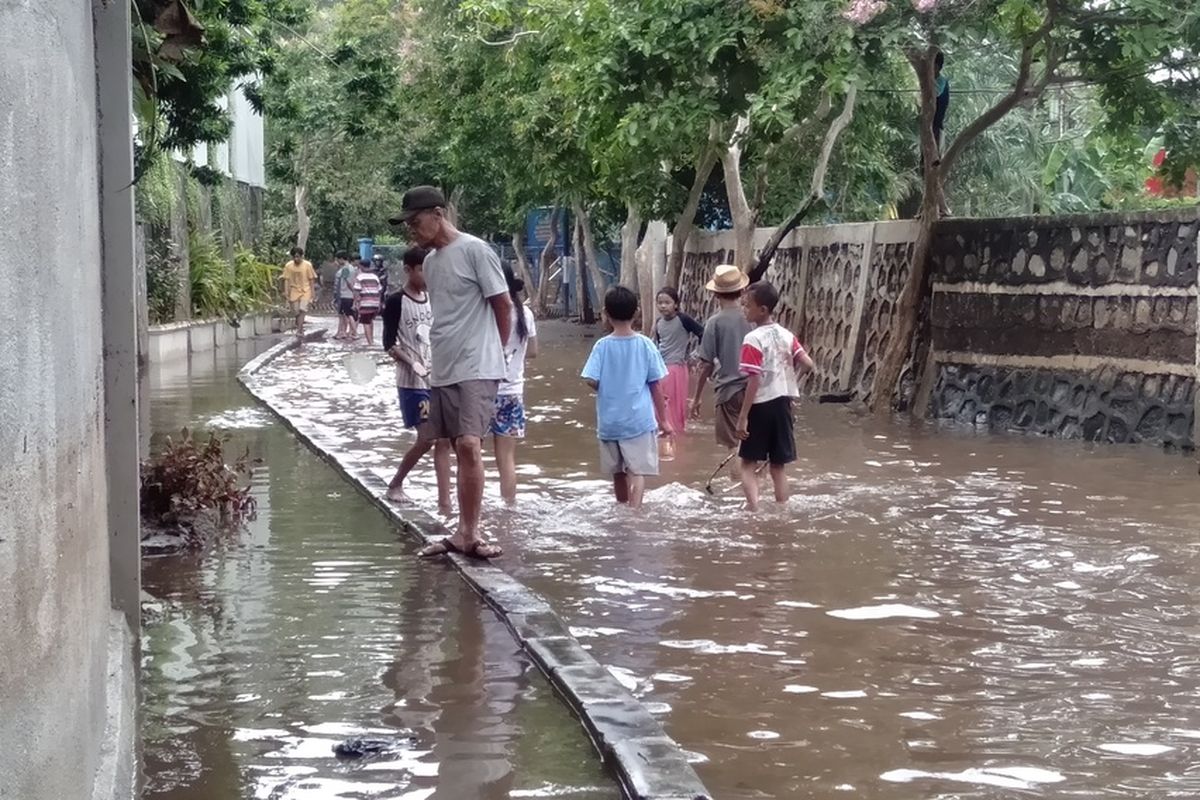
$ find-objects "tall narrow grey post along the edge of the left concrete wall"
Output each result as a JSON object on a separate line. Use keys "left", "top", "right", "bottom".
{"left": 92, "top": 0, "right": 142, "bottom": 638}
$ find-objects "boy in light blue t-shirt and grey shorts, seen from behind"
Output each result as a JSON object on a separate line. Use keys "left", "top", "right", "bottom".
{"left": 582, "top": 285, "right": 673, "bottom": 509}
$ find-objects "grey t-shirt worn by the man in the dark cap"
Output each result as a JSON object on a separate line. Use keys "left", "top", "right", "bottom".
{"left": 425, "top": 233, "right": 509, "bottom": 386}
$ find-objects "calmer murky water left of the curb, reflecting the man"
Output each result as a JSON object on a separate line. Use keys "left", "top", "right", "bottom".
{"left": 142, "top": 342, "right": 620, "bottom": 800}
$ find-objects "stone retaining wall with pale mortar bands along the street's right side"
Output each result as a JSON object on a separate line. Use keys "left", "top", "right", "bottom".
{"left": 682, "top": 210, "right": 1200, "bottom": 447}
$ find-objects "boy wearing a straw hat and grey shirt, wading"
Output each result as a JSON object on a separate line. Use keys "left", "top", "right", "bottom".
{"left": 691, "top": 264, "right": 754, "bottom": 447}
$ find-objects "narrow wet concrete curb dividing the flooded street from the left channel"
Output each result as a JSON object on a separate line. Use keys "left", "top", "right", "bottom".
{"left": 238, "top": 330, "right": 712, "bottom": 800}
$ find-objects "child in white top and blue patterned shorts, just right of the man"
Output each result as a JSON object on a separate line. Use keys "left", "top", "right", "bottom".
{"left": 492, "top": 265, "right": 538, "bottom": 505}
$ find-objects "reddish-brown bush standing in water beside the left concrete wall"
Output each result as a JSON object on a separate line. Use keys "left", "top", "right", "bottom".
{"left": 140, "top": 428, "right": 257, "bottom": 524}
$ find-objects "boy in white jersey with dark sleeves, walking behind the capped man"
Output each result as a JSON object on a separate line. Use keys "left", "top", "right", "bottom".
{"left": 383, "top": 247, "right": 450, "bottom": 515}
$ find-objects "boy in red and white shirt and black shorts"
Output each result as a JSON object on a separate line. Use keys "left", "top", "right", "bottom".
{"left": 738, "top": 281, "right": 814, "bottom": 511}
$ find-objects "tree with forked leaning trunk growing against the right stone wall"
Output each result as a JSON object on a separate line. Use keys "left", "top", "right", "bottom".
{"left": 846, "top": 0, "right": 1200, "bottom": 409}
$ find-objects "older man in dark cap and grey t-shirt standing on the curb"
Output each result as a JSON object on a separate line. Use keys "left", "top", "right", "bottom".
{"left": 390, "top": 186, "right": 512, "bottom": 559}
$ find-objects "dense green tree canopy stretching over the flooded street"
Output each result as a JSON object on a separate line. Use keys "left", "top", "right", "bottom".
{"left": 131, "top": 0, "right": 1200, "bottom": 262}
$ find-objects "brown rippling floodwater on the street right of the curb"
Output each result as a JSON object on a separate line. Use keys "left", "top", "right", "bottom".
{"left": 259, "top": 323, "right": 1200, "bottom": 800}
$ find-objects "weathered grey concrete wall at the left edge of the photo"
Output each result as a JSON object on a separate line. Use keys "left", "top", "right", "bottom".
{"left": 0, "top": 0, "right": 136, "bottom": 800}
